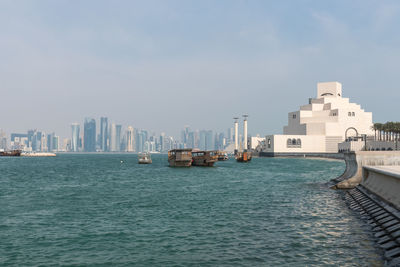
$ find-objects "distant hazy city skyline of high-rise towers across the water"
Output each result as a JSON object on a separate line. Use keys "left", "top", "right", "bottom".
{"left": 0, "top": 117, "right": 251, "bottom": 153}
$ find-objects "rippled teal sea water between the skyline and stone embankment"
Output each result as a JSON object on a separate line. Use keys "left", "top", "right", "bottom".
{"left": 0, "top": 155, "right": 383, "bottom": 266}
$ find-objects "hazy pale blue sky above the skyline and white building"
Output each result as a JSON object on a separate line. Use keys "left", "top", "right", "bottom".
{"left": 0, "top": 0, "right": 400, "bottom": 137}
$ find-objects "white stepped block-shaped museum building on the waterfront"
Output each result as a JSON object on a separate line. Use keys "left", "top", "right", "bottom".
{"left": 260, "top": 82, "right": 373, "bottom": 156}
